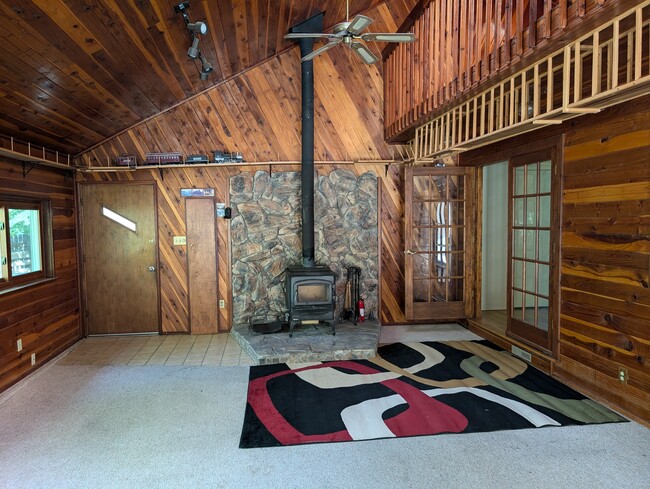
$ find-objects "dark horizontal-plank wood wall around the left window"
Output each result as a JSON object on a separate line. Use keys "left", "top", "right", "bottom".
{"left": 0, "top": 157, "right": 81, "bottom": 391}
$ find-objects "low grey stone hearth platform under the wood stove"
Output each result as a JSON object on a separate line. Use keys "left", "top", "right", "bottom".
{"left": 230, "top": 321, "right": 381, "bottom": 365}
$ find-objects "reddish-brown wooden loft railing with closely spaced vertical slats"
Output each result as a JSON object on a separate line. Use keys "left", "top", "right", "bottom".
{"left": 384, "top": 0, "right": 624, "bottom": 142}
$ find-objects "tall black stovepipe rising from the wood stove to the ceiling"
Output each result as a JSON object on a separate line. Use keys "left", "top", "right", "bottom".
{"left": 290, "top": 12, "right": 324, "bottom": 268}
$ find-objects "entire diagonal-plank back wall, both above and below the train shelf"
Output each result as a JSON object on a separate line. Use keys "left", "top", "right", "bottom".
{"left": 78, "top": 2, "right": 409, "bottom": 333}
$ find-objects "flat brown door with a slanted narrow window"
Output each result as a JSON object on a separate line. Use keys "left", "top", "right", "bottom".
{"left": 79, "top": 184, "right": 160, "bottom": 335}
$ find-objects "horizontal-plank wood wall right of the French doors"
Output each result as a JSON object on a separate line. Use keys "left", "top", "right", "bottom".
{"left": 555, "top": 97, "right": 650, "bottom": 421}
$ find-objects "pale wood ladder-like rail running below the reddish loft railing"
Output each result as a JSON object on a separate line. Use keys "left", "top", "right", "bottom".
{"left": 412, "top": 0, "right": 650, "bottom": 162}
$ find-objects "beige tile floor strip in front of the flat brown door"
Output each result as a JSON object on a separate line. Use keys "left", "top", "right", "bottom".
{"left": 57, "top": 333, "right": 255, "bottom": 367}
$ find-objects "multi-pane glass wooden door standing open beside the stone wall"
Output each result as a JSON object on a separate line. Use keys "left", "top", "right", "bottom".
{"left": 405, "top": 167, "right": 475, "bottom": 321}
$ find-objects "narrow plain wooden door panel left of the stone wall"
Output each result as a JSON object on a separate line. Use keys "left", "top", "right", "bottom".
{"left": 185, "top": 198, "right": 219, "bottom": 334}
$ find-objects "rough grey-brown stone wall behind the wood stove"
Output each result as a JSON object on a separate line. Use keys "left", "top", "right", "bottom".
{"left": 230, "top": 169, "right": 378, "bottom": 325}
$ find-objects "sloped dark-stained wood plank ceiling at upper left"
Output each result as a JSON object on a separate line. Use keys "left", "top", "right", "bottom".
{"left": 0, "top": 0, "right": 417, "bottom": 154}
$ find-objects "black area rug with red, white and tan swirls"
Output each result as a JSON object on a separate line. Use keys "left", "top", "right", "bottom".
{"left": 239, "top": 341, "right": 625, "bottom": 448}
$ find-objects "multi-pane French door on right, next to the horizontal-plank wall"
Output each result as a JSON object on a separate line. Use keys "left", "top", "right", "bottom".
{"left": 507, "top": 150, "right": 560, "bottom": 352}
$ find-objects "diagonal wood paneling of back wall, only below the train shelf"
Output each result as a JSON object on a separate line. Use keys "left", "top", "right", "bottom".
{"left": 78, "top": 163, "right": 405, "bottom": 333}
